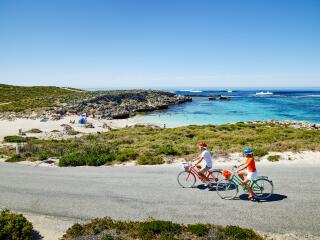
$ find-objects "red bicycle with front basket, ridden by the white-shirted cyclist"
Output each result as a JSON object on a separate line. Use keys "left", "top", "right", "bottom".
{"left": 177, "top": 162, "right": 222, "bottom": 188}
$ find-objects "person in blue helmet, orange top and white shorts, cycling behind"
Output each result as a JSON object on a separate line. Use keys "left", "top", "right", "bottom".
{"left": 235, "top": 148, "right": 257, "bottom": 200}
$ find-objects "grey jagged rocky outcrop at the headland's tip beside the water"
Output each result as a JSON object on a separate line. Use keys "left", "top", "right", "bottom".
{"left": 56, "top": 91, "right": 192, "bottom": 119}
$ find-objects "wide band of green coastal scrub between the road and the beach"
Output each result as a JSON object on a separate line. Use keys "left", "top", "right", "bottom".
{"left": 0, "top": 122, "right": 320, "bottom": 167}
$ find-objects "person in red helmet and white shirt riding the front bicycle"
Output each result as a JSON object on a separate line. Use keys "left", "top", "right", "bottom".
{"left": 193, "top": 142, "right": 212, "bottom": 181}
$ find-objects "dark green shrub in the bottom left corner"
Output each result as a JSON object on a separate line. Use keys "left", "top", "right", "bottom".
{"left": 0, "top": 210, "right": 32, "bottom": 240}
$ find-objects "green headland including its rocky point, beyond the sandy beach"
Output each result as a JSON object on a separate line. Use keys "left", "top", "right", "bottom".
{"left": 0, "top": 84, "right": 191, "bottom": 118}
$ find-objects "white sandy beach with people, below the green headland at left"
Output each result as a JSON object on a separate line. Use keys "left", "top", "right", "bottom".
{"left": 0, "top": 115, "right": 136, "bottom": 141}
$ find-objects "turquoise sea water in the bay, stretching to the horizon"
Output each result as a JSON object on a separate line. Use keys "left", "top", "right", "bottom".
{"left": 133, "top": 90, "right": 320, "bottom": 127}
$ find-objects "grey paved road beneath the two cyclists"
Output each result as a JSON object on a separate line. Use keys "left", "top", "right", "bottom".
{"left": 0, "top": 163, "right": 320, "bottom": 235}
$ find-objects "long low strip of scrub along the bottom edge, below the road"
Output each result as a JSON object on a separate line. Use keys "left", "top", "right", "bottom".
{"left": 62, "top": 217, "right": 263, "bottom": 240}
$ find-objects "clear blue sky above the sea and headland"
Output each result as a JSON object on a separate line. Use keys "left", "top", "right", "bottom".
{"left": 0, "top": 0, "right": 320, "bottom": 88}
